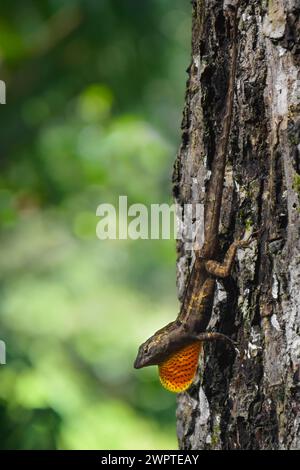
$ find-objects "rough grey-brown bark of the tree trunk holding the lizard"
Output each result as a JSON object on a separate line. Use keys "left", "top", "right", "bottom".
{"left": 173, "top": 0, "right": 300, "bottom": 449}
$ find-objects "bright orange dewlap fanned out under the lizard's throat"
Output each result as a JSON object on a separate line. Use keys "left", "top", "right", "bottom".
{"left": 158, "top": 341, "right": 202, "bottom": 393}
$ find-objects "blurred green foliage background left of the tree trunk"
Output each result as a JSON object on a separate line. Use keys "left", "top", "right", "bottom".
{"left": 0, "top": 0, "right": 191, "bottom": 449}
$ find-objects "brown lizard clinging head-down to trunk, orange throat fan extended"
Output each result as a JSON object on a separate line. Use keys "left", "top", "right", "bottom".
{"left": 134, "top": 1, "right": 250, "bottom": 392}
